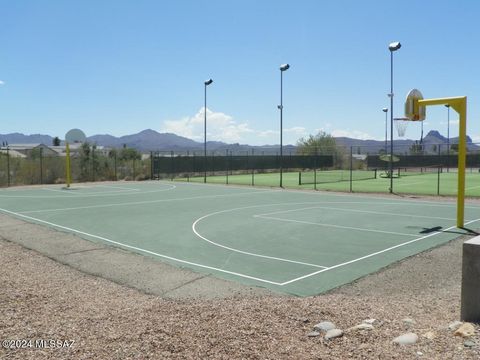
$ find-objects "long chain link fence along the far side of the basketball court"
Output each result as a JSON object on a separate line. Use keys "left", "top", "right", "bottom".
{"left": 0, "top": 142, "right": 480, "bottom": 197}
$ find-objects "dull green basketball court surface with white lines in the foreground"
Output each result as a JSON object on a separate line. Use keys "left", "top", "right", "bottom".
{"left": 0, "top": 181, "right": 480, "bottom": 296}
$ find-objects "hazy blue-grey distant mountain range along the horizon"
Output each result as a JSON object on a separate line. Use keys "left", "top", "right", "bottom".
{"left": 0, "top": 129, "right": 480, "bottom": 154}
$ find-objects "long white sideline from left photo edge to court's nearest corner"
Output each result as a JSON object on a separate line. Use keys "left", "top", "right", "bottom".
{"left": 0, "top": 208, "right": 281, "bottom": 285}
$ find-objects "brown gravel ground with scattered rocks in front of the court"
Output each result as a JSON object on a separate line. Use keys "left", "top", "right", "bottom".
{"left": 0, "top": 219, "right": 480, "bottom": 359}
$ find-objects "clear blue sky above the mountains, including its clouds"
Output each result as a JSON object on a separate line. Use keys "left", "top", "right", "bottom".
{"left": 0, "top": 0, "right": 480, "bottom": 144}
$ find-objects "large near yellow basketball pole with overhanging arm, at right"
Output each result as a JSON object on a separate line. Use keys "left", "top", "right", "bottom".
{"left": 418, "top": 96, "right": 467, "bottom": 228}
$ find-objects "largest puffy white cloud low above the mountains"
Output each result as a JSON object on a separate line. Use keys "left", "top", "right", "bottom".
{"left": 162, "top": 107, "right": 255, "bottom": 142}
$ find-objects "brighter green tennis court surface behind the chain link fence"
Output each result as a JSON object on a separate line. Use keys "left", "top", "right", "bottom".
{"left": 176, "top": 169, "right": 480, "bottom": 197}
